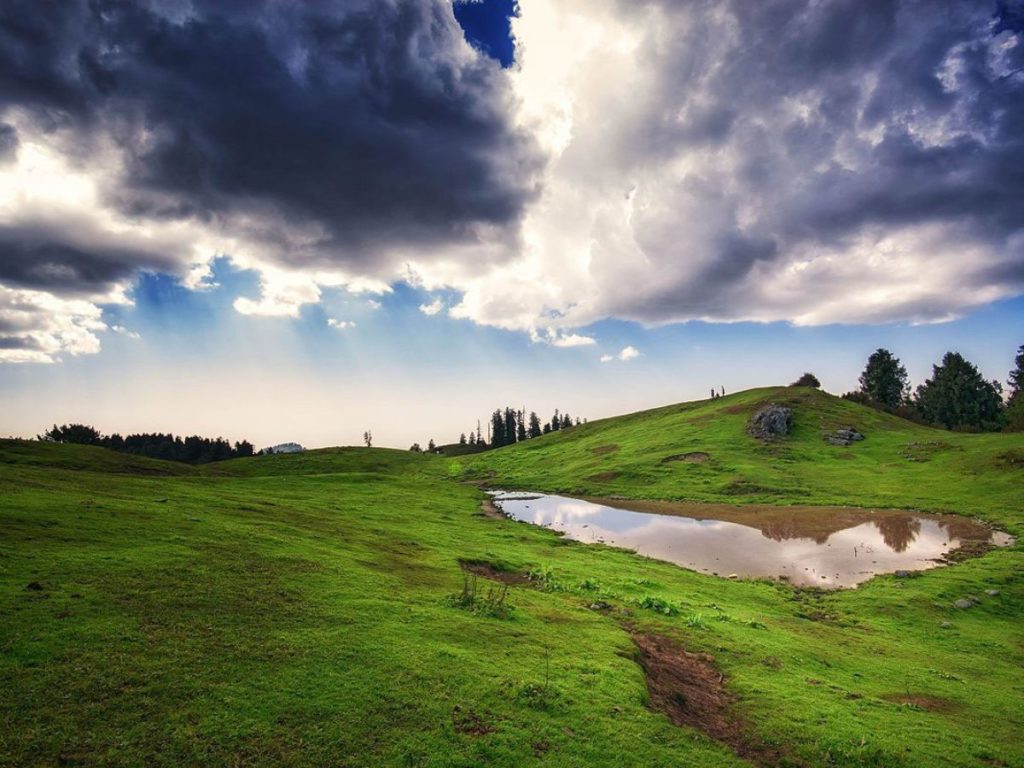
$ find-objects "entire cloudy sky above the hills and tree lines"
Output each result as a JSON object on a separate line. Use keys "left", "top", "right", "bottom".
{"left": 0, "top": 0, "right": 1024, "bottom": 447}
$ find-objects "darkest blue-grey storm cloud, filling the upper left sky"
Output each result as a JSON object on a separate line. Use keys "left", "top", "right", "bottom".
{"left": 0, "top": 0, "right": 539, "bottom": 270}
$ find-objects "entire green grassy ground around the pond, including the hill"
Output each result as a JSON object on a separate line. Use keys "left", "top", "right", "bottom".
{"left": 0, "top": 390, "right": 1024, "bottom": 768}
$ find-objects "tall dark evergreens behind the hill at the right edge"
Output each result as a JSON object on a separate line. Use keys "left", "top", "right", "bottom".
{"left": 843, "top": 345, "right": 1024, "bottom": 432}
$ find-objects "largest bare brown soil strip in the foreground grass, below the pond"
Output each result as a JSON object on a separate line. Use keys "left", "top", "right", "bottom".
{"left": 633, "top": 633, "right": 782, "bottom": 766}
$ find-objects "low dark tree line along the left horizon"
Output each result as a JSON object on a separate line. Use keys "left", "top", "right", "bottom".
{"left": 38, "top": 424, "right": 254, "bottom": 464}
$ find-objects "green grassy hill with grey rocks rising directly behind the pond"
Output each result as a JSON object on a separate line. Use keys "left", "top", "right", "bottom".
{"left": 458, "top": 387, "right": 1024, "bottom": 532}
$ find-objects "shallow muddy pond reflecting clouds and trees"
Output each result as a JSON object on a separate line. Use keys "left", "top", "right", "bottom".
{"left": 493, "top": 492, "right": 1013, "bottom": 588}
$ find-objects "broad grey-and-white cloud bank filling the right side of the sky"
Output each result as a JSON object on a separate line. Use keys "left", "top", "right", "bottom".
{"left": 585, "top": 0, "right": 1024, "bottom": 322}
